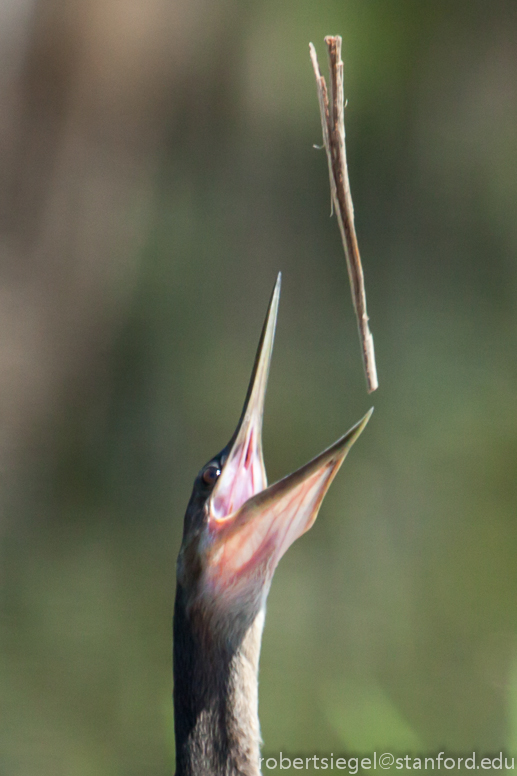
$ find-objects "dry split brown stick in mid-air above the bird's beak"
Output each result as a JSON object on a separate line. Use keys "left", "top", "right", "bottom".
{"left": 309, "top": 35, "right": 379, "bottom": 393}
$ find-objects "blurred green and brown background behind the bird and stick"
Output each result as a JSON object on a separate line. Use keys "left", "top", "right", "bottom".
{"left": 0, "top": 0, "right": 517, "bottom": 776}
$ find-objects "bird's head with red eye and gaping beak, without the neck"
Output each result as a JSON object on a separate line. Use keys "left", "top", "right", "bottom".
{"left": 177, "top": 275, "right": 373, "bottom": 622}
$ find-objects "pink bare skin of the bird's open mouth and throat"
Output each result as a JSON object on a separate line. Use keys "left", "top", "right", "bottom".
{"left": 202, "top": 423, "right": 354, "bottom": 597}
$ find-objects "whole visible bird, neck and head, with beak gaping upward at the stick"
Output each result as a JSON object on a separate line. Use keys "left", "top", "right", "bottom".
{"left": 174, "top": 275, "right": 371, "bottom": 776}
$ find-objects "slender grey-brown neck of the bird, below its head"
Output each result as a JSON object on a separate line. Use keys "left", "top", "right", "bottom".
{"left": 174, "top": 586, "right": 264, "bottom": 776}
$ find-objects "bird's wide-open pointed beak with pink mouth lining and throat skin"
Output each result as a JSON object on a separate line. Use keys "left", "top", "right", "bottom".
{"left": 209, "top": 275, "right": 373, "bottom": 587}
